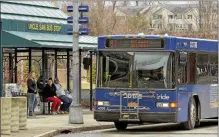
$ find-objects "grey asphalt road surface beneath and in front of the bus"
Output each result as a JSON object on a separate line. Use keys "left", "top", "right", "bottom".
{"left": 56, "top": 120, "right": 218, "bottom": 137}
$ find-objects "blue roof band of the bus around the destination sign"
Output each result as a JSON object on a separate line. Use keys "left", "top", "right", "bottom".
{"left": 98, "top": 34, "right": 218, "bottom": 52}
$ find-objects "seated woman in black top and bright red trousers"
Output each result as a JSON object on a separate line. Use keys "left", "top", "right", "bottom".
{"left": 42, "top": 78, "right": 61, "bottom": 115}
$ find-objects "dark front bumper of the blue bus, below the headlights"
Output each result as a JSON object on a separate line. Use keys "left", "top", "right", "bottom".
{"left": 94, "top": 111, "right": 177, "bottom": 123}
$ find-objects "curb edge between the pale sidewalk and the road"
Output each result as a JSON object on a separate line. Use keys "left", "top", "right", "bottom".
{"left": 34, "top": 125, "right": 115, "bottom": 137}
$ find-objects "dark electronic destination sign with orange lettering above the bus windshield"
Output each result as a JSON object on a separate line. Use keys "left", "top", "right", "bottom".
{"left": 105, "top": 39, "right": 164, "bottom": 49}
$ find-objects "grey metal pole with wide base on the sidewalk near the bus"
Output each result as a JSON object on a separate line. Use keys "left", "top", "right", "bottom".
{"left": 69, "top": 0, "right": 84, "bottom": 124}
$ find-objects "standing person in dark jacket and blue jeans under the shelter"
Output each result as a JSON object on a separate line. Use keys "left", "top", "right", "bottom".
{"left": 27, "top": 72, "right": 37, "bottom": 116}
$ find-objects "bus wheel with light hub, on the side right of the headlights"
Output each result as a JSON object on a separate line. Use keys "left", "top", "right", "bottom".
{"left": 182, "top": 97, "right": 197, "bottom": 130}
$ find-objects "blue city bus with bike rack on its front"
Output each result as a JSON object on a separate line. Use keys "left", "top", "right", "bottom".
{"left": 93, "top": 35, "right": 218, "bottom": 130}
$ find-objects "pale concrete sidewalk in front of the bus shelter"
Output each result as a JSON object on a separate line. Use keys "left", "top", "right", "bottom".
{"left": 2, "top": 110, "right": 113, "bottom": 137}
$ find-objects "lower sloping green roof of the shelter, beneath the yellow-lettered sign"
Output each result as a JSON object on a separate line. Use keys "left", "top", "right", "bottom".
{"left": 2, "top": 31, "right": 97, "bottom": 49}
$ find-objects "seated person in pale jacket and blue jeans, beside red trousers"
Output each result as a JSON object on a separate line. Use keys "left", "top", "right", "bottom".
{"left": 54, "top": 78, "right": 72, "bottom": 113}
